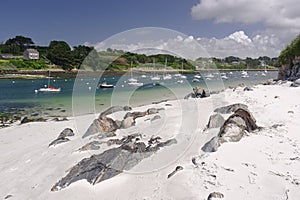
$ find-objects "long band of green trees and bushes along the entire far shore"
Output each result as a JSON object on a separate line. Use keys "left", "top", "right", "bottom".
{"left": 0, "top": 36, "right": 278, "bottom": 71}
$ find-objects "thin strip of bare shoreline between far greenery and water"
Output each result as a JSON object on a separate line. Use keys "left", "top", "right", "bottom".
{"left": 0, "top": 69, "right": 278, "bottom": 79}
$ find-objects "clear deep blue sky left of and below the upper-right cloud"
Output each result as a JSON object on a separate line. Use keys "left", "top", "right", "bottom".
{"left": 0, "top": 0, "right": 257, "bottom": 45}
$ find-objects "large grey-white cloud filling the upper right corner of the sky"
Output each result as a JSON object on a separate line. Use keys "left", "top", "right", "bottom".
{"left": 191, "top": 0, "right": 300, "bottom": 48}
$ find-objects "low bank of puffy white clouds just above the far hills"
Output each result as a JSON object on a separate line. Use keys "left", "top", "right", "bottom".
{"left": 88, "top": 31, "right": 280, "bottom": 60}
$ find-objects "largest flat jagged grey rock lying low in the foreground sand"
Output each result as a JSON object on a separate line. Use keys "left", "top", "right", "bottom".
{"left": 51, "top": 136, "right": 177, "bottom": 191}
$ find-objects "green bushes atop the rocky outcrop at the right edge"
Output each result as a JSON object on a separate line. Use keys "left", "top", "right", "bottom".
{"left": 277, "top": 35, "right": 300, "bottom": 66}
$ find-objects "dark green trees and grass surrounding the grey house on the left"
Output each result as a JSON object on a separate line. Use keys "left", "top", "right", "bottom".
{"left": 0, "top": 36, "right": 94, "bottom": 70}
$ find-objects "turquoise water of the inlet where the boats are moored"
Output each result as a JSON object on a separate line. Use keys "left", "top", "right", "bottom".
{"left": 0, "top": 71, "right": 277, "bottom": 117}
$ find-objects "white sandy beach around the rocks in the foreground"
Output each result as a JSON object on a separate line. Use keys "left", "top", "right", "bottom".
{"left": 0, "top": 83, "right": 300, "bottom": 200}
